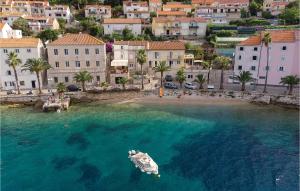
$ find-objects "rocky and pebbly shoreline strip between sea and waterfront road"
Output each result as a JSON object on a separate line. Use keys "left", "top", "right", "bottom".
{"left": 0, "top": 90, "right": 300, "bottom": 110}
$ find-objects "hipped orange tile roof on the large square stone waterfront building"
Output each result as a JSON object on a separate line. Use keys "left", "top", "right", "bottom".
{"left": 48, "top": 33, "right": 104, "bottom": 46}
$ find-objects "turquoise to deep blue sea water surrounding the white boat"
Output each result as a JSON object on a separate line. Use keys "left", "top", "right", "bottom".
{"left": 1, "top": 103, "right": 299, "bottom": 191}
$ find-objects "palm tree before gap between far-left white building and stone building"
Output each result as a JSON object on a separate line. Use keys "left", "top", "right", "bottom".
{"left": 22, "top": 58, "right": 51, "bottom": 94}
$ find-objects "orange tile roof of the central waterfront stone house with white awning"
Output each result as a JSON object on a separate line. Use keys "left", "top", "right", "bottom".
{"left": 149, "top": 41, "right": 185, "bottom": 50}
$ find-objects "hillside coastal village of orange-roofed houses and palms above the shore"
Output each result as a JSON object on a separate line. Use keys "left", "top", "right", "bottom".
{"left": 0, "top": 0, "right": 300, "bottom": 107}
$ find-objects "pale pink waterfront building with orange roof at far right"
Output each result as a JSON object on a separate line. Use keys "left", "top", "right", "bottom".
{"left": 234, "top": 30, "right": 300, "bottom": 85}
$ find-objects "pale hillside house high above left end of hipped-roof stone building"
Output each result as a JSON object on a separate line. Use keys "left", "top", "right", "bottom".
{"left": 45, "top": 5, "right": 72, "bottom": 22}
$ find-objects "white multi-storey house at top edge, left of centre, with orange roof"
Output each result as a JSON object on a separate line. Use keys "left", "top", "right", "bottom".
{"left": 123, "top": 1, "right": 150, "bottom": 23}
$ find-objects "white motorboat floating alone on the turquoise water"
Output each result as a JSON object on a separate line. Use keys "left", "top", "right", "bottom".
{"left": 128, "top": 150, "right": 160, "bottom": 177}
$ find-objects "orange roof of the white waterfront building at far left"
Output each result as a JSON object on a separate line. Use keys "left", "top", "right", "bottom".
{"left": 0, "top": 37, "right": 41, "bottom": 48}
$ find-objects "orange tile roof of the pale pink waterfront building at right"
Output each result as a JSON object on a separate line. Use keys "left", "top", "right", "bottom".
{"left": 239, "top": 30, "right": 299, "bottom": 46}
